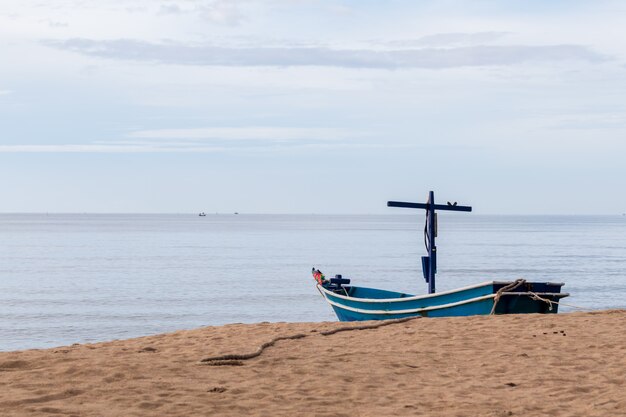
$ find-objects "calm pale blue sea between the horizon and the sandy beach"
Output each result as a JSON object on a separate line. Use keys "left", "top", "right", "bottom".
{"left": 0, "top": 213, "right": 626, "bottom": 350}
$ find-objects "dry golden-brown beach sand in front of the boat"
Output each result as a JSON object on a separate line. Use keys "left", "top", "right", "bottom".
{"left": 0, "top": 310, "right": 626, "bottom": 417}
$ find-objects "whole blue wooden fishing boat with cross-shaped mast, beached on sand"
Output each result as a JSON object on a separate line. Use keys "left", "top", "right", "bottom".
{"left": 313, "top": 191, "right": 569, "bottom": 321}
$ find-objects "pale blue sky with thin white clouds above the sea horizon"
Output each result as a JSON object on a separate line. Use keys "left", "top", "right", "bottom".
{"left": 0, "top": 0, "right": 626, "bottom": 215}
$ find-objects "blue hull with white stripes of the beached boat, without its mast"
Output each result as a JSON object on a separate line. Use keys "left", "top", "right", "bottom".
{"left": 318, "top": 281, "right": 569, "bottom": 321}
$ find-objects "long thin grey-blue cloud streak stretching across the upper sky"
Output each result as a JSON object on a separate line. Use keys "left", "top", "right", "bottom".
{"left": 45, "top": 39, "right": 608, "bottom": 69}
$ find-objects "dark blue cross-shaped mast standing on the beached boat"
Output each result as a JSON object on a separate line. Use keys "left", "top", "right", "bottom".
{"left": 387, "top": 191, "right": 472, "bottom": 294}
